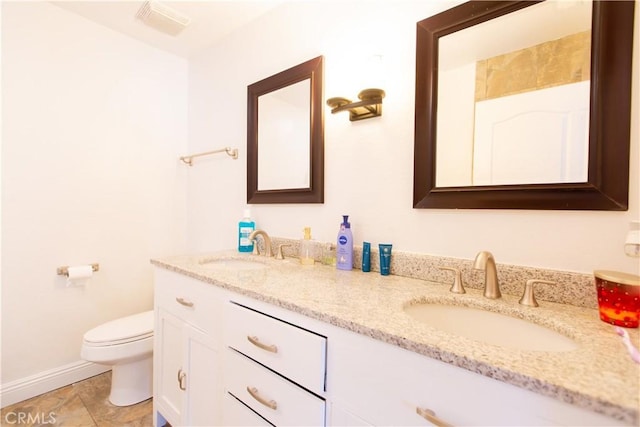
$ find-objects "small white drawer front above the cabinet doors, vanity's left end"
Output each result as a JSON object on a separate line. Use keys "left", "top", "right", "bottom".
{"left": 154, "top": 270, "right": 224, "bottom": 335}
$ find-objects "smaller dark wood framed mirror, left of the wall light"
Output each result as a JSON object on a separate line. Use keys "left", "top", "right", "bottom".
{"left": 247, "top": 56, "right": 324, "bottom": 204}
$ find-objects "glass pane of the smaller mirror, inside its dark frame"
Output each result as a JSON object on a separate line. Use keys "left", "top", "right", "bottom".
{"left": 258, "top": 79, "right": 311, "bottom": 191}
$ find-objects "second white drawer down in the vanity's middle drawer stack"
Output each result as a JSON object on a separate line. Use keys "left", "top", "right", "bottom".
{"left": 225, "top": 349, "right": 325, "bottom": 426}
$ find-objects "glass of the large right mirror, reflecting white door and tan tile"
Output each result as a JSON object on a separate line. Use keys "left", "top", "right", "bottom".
{"left": 436, "top": 1, "right": 591, "bottom": 187}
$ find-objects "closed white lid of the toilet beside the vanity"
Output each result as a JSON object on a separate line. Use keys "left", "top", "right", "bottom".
{"left": 84, "top": 310, "right": 153, "bottom": 345}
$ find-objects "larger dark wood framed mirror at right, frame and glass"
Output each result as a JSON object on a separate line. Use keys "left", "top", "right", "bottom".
{"left": 414, "top": 0, "right": 635, "bottom": 210}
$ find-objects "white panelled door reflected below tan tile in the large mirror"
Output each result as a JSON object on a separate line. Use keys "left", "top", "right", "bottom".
{"left": 472, "top": 81, "right": 589, "bottom": 185}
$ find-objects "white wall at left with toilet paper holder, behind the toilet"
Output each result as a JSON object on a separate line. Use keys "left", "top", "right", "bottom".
{"left": 2, "top": 2, "right": 188, "bottom": 386}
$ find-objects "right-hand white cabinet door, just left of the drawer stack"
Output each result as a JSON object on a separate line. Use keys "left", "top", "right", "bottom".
{"left": 182, "top": 325, "right": 222, "bottom": 426}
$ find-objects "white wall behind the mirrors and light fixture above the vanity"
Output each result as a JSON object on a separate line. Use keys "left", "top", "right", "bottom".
{"left": 188, "top": 1, "right": 640, "bottom": 274}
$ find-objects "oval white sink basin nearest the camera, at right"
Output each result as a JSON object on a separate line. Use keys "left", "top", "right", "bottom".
{"left": 404, "top": 303, "right": 578, "bottom": 352}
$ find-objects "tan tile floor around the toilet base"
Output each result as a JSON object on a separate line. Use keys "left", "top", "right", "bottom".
{"left": 0, "top": 371, "right": 153, "bottom": 427}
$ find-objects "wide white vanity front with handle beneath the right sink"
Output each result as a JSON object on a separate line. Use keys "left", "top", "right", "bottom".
{"left": 329, "top": 326, "right": 624, "bottom": 426}
